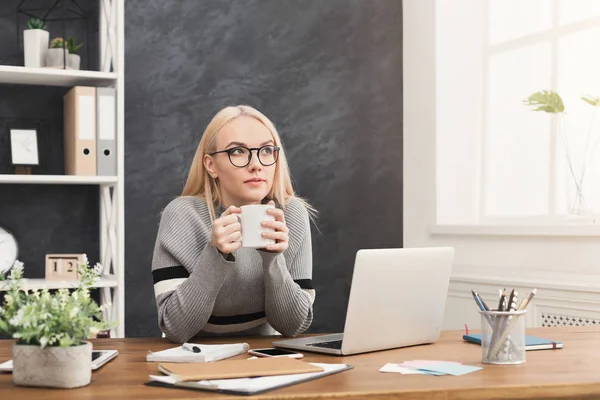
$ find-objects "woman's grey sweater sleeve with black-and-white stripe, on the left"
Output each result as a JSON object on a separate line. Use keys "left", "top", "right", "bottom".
{"left": 152, "top": 197, "right": 234, "bottom": 342}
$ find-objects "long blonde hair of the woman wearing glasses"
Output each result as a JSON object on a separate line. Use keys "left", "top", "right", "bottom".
{"left": 181, "top": 105, "right": 316, "bottom": 220}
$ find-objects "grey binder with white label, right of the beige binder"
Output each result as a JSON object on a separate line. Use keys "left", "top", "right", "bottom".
{"left": 96, "top": 88, "right": 117, "bottom": 176}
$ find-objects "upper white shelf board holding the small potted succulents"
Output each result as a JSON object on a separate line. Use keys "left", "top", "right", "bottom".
{"left": 0, "top": 65, "right": 117, "bottom": 87}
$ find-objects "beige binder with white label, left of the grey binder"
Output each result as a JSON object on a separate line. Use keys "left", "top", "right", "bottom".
{"left": 63, "top": 86, "right": 96, "bottom": 176}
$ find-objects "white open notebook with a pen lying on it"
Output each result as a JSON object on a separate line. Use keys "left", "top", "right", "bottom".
{"left": 146, "top": 343, "right": 250, "bottom": 363}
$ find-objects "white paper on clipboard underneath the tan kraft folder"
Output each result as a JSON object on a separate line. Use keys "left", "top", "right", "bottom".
{"left": 145, "top": 357, "right": 353, "bottom": 396}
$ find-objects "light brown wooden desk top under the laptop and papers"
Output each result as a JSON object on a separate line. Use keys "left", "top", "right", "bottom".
{"left": 0, "top": 328, "right": 600, "bottom": 400}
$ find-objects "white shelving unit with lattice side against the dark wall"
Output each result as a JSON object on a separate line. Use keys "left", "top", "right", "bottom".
{"left": 0, "top": 0, "right": 125, "bottom": 338}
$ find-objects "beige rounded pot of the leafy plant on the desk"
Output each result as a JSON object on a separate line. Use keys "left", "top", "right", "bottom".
{"left": 12, "top": 342, "right": 92, "bottom": 389}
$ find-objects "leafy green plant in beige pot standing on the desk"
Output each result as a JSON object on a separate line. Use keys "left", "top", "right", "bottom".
{"left": 0, "top": 258, "right": 113, "bottom": 388}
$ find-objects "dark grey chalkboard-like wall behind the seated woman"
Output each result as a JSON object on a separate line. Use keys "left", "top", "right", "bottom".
{"left": 125, "top": 0, "right": 402, "bottom": 336}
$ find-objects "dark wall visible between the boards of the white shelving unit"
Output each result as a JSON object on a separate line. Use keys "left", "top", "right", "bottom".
{"left": 0, "top": 0, "right": 99, "bottom": 278}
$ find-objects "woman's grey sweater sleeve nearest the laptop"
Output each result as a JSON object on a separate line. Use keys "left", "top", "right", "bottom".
{"left": 260, "top": 199, "right": 315, "bottom": 336}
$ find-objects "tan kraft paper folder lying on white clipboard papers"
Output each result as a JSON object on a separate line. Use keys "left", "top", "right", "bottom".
{"left": 158, "top": 357, "right": 323, "bottom": 381}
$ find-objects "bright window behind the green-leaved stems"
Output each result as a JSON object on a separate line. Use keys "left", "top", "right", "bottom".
{"left": 436, "top": 0, "right": 600, "bottom": 224}
